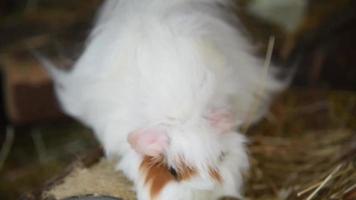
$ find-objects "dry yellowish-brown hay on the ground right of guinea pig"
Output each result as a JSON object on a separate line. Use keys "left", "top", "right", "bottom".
{"left": 248, "top": 130, "right": 356, "bottom": 200}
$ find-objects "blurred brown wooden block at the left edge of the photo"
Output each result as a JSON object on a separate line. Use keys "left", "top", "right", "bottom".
{"left": 0, "top": 51, "right": 64, "bottom": 125}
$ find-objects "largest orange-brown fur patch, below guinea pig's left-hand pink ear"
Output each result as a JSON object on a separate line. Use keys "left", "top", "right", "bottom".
{"left": 140, "top": 156, "right": 197, "bottom": 199}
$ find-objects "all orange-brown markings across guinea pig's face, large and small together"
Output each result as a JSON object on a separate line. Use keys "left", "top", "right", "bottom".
{"left": 140, "top": 153, "right": 225, "bottom": 199}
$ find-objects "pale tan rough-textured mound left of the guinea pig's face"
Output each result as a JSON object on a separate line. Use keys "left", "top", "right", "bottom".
{"left": 42, "top": 159, "right": 135, "bottom": 200}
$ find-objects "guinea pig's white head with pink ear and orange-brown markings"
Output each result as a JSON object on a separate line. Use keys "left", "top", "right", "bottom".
{"left": 129, "top": 124, "right": 248, "bottom": 199}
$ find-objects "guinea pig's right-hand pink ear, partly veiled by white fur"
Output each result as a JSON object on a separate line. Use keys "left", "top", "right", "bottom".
{"left": 206, "top": 109, "right": 237, "bottom": 133}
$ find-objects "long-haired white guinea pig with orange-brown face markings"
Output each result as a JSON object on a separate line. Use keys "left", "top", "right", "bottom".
{"left": 42, "top": 0, "right": 285, "bottom": 200}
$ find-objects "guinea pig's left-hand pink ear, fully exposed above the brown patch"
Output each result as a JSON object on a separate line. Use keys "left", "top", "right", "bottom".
{"left": 127, "top": 127, "right": 169, "bottom": 157}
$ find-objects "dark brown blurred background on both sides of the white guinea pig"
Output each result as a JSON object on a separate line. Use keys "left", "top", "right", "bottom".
{"left": 0, "top": 0, "right": 356, "bottom": 200}
